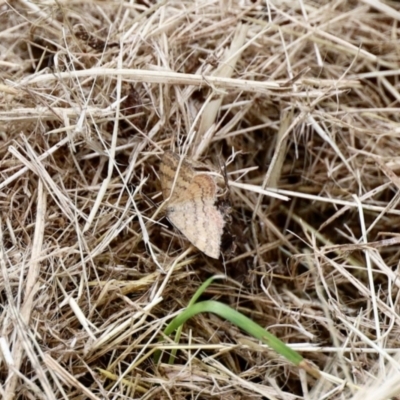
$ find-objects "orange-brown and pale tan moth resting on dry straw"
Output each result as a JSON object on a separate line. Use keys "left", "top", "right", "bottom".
{"left": 160, "top": 152, "right": 225, "bottom": 259}
